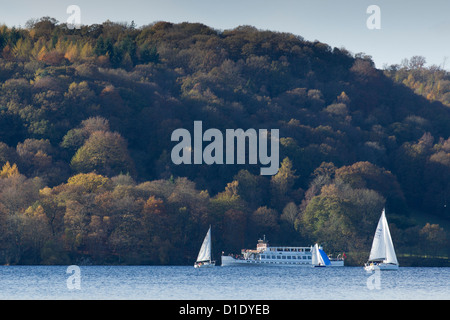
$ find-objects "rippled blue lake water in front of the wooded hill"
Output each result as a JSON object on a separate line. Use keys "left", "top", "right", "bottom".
{"left": 0, "top": 266, "right": 450, "bottom": 300}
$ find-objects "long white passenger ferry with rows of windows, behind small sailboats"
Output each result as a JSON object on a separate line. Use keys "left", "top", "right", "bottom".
{"left": 222, "top": 237, "right": 344, "bottom": 267}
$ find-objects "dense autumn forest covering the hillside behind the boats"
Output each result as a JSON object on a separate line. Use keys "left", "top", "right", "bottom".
{"left": 0, "top": 17, "right": 450, "bottom": 264}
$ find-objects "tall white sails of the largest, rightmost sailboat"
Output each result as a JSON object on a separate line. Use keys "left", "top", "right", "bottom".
{"left": 369, "top": 209, "right": 398, "bottom": 264}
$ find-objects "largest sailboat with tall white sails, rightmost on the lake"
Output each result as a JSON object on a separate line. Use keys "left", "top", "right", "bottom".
{"left": 364, "top": 209, "right": 398, "bottom": 271}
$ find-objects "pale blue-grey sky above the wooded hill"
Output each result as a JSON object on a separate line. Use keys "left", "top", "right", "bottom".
{"left": 0, "top": 0, "right": 450, "bottom": 70}
